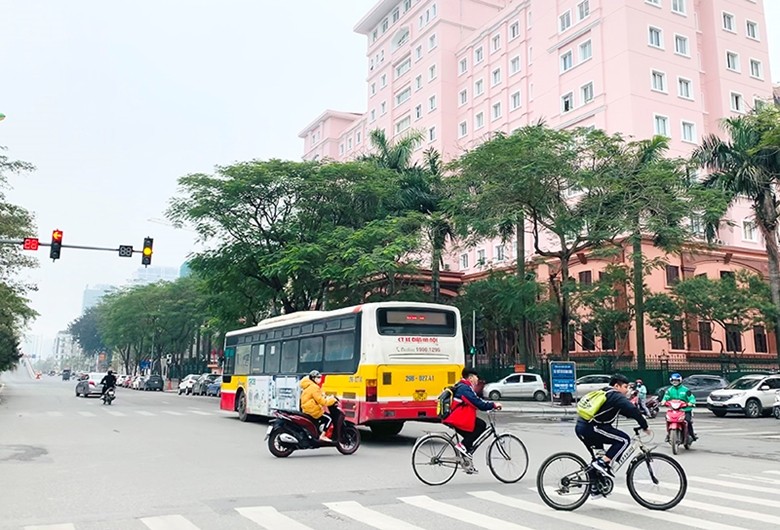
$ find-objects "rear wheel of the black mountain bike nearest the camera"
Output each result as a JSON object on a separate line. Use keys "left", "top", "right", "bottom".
{"left": 536, "top": 453, "right": 590, "bottom": 511}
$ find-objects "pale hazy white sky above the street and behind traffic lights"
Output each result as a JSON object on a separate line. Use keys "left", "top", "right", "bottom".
{"left": 0, "top": 0, "right": 780, "bottom": 336}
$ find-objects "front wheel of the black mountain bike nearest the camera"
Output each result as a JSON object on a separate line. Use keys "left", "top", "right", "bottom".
{"left": 626, "top": 453, "right": 688, "bottom": 510}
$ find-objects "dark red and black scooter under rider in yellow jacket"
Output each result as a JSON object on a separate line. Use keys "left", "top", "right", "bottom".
{"left": 266, "top": 402, "right": 360, "bottom": 458}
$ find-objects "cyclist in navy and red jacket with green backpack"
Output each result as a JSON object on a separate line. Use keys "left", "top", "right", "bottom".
{"left": 442, "top": 368, "right": 501, "bottom": 474}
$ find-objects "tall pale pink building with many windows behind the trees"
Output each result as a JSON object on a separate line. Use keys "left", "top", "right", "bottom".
{"left": 300, "top": 0, "right": 774, "bottom": 364}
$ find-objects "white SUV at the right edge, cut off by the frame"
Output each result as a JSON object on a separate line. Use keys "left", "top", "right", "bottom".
{"left": 707, "top": 374, "right": 780, "bottom": 418}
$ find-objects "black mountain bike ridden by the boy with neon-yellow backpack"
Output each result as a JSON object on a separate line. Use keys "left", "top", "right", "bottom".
{"left": 536, "top": 427, "right": 688, "bottom": 510}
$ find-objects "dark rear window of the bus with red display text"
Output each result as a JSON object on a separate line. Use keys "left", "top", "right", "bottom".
{"left": 376, "top": 308, "right": 457, "bottom": 337}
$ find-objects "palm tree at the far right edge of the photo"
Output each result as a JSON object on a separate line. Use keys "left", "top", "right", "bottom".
{"left": 693, "top": 108, "right": 780, "bottom": 358}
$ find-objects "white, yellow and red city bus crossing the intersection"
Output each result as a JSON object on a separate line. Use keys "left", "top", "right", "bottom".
{"left": 220, "top": 302, "right": 464, "bottom": 436}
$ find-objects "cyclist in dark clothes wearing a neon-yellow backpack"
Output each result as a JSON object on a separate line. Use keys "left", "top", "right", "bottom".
{"left": 574, "top": 374, "right": 650, "bottom": 482}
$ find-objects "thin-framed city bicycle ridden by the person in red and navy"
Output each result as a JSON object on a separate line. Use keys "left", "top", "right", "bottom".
{"left": 412, "top": 411, "right": 528, "bottom": 486}
